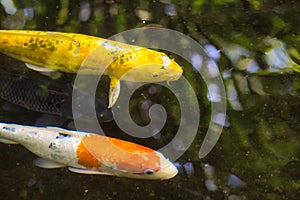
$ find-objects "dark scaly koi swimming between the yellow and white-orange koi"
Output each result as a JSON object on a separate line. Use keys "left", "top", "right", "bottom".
{"left": 0, "top": 70, "right": 113, "bottom": 122}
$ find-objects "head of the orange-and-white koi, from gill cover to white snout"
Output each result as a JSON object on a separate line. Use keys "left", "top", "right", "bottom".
{"left": 103, "top": 138, "right": 178, "bottom": 180}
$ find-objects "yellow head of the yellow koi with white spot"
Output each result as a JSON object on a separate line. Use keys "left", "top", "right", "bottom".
{"left": 112, "top": 47, "right": 183, "bottom": 82}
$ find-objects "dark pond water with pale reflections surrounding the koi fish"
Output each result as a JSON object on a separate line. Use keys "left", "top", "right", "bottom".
{"left": 0, "top": 0, "right": 300, "bottom": 200}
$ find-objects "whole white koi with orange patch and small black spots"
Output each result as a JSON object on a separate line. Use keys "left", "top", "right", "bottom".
{"left": 0, "top": 123, "right": 178, "bottom": 180}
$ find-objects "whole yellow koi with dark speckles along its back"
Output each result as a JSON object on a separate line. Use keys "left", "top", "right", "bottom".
{"left": 0, "top": 30, "right": 182, "bottom": 108}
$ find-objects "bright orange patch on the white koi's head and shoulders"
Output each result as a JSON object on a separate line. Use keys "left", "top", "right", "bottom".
{"left": 79, "top": 134, "right": 160, "bottom": 173}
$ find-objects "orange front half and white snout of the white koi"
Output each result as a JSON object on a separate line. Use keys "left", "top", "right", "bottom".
{"left": 78, "top": 134, "right": 178, "bottom": 180}
